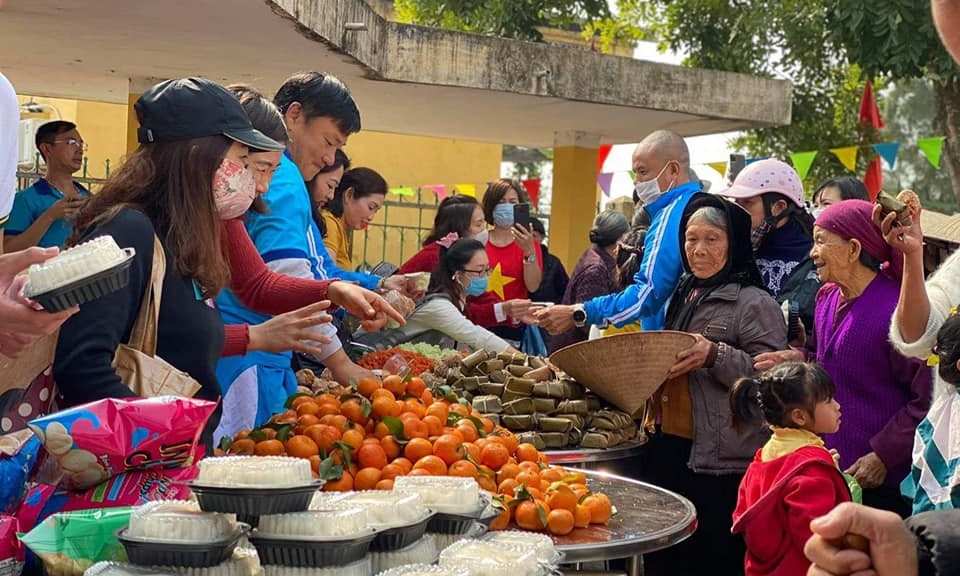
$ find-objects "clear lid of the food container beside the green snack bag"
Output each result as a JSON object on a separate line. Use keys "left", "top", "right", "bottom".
{"left": 126, "top": 500, "right": 237, "bottom": 543}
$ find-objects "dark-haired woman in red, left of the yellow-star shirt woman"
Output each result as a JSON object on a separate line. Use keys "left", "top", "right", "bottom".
{"left": 397, "top": 194, "right": 488, "bottom": 274}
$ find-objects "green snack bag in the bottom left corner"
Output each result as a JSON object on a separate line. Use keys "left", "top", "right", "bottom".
{"left": 21, "top": 508, "right": 130, "bottom": 576}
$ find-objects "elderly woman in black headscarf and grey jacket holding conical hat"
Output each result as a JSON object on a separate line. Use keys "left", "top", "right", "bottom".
{"left": 640, "top": 194, "right": 787, "bottom": 576}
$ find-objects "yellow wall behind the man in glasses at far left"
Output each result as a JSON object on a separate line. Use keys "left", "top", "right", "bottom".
{"left": 18, "top": 95, "right": 127, "bottom": 178}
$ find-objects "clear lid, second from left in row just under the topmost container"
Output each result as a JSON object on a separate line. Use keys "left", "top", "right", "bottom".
{"left": 257, "top": 507, "right": 370, "bottom": 540}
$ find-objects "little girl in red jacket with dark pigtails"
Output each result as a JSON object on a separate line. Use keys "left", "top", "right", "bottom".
{"left": 730, "top": 362, "right": 850, "bottom": 576}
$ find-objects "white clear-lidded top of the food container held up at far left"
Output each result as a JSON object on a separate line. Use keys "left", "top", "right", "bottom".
{"left": 27, "top": 236, "right": 129, "bottom": 296}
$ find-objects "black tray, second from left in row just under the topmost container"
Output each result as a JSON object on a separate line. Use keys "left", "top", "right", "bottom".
{"left": 249, "top": 530, "right": 377, "bottom": 568}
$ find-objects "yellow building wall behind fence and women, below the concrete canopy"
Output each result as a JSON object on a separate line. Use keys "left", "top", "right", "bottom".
{"left": 344, "top": 131, "right": 503, "bottom": 266}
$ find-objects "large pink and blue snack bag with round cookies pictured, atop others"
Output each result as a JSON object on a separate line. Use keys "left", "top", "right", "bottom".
{"left": 29, "top": 396, "right": 217, "bottom": 490}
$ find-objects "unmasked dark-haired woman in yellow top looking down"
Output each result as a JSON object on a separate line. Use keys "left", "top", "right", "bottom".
{"left": 323, "top": 168, "right": 388, "bottom": 270}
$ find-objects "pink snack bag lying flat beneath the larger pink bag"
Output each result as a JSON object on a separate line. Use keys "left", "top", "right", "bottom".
{"left": 17, "top": 466, "right": 197, "bottom": 532}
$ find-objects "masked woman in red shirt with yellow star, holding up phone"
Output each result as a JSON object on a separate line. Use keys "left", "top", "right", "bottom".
{"left": 468, "top": 178, "right": 543, "bottom": 341}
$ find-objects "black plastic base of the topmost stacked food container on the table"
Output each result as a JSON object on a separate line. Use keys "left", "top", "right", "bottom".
{"left": 187, "top": 480, "right": 323, "bottom": 520}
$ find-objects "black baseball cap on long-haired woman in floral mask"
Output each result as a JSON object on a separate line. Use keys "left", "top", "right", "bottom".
{"left": 133, "top": 78, "right": 284, "bottom": 150}
